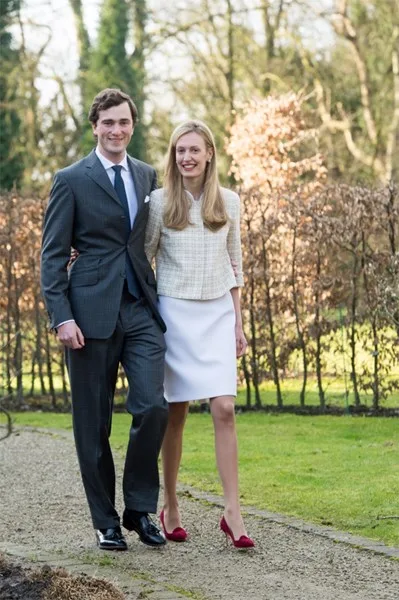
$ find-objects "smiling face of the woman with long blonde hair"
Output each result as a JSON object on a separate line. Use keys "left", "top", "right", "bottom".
{"left": 176, "top": 131, "right": 213, "bottom": 179}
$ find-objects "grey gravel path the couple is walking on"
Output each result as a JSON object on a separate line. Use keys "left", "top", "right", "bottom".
{"left": 0, "top": 430, "right": 399, "bottom": 600}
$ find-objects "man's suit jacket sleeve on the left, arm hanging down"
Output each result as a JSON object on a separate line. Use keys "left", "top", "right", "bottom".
{"left": 41, "top": 173, "right": 75, "bottom": 328}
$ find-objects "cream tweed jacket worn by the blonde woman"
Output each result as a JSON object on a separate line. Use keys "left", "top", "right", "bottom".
{"left": 145, "top": 188, "right": 244, "bottom": 300}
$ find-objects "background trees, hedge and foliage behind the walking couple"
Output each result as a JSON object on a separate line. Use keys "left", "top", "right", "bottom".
{"left": 0, "top": 0, "right": 399, "bottom": 410}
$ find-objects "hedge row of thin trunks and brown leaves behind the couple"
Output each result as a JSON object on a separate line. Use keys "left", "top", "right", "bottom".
{"left": 0, "top": 186, "right": 399, "bottom": 409}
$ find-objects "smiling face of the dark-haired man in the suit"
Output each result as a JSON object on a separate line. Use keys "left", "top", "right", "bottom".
{"left": 92, "top": 102, "right": 134, "bottom": 163}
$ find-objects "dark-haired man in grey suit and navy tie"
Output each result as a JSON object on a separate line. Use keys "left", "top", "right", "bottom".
{"left": 41, "top": 89, "right": 167, "bottom": 550}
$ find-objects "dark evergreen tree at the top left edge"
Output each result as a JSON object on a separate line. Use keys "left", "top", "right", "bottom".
{"left": 0, "top": 0, "right": 24, "bottom": 190}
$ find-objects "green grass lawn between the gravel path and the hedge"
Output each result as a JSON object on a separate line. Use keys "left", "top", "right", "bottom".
{"left": 9, "top": 413, "right": 399, "bottom": 546}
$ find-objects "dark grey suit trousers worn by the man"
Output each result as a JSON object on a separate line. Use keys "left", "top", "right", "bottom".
{"left": 67, "top": 292, "right": 168, "bottom": 529}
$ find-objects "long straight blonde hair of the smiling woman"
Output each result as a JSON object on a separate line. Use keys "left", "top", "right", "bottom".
{"left": 164, "top": 120, "right": 228, "bottom": 231}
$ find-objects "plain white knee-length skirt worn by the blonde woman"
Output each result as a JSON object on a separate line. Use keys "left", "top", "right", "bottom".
{"left": 159, "top": 292, "right": 237, "bottom": 402}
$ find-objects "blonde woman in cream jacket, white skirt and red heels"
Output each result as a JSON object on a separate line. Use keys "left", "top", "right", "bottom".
{"left": 146, "top": 121, "right": 254, "bottom": 548}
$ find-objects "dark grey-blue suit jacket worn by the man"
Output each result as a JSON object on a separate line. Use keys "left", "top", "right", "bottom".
{"left": 41, "top": 150, "right": 166, "bottom": 339}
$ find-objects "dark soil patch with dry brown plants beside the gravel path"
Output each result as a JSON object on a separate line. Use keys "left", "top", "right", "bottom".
{"left": 0, "top": 555, "right": 125, "bottom": 600}
